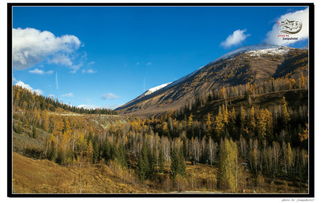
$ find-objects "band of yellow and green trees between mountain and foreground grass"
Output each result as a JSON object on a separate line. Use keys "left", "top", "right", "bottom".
{"left": 13, "top": 73, "right": 309, "bottom": 192}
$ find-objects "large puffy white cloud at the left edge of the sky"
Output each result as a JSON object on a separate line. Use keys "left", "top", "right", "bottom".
{"left": 12, "top": 28, "right": 81, "bottom": 70}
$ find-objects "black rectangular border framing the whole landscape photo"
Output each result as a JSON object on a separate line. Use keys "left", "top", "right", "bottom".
{"left": 7, "top": 3, "right": 315, "bottom": 198}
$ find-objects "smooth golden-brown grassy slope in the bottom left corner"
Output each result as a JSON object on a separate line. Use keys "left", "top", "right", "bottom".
{"left": 13, "top": 153, "right": 157, "bottom": 193}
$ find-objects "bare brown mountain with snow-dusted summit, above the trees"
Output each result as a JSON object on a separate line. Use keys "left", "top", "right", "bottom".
{"left": 116, "top": 45, "right": 308, "bottom": 115}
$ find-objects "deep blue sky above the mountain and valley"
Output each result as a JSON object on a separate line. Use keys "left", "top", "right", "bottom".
{"left": 13, "top": 7, "right": 307, "bottom": 108}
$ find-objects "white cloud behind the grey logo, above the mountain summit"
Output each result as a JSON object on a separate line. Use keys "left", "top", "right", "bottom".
{"left": 265, "top": 8, "right": 309, "bottom": 45}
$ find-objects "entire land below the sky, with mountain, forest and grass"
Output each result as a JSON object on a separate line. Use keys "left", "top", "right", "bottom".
{"left": 12, "top": 46, "right": 309, "bottom": 194}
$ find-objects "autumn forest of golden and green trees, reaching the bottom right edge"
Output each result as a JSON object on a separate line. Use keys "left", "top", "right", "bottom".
{"left": 13, "top": 72, "right": 309, "bottom": 193}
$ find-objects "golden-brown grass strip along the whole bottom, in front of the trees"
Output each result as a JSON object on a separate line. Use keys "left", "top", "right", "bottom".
{"left": 13, "top": 153, "right": 307, "bottom": 193}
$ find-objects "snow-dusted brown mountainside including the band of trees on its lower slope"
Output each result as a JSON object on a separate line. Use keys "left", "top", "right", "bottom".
{"left": 116, "top": 46, "right": 308, "bottom": 116}
